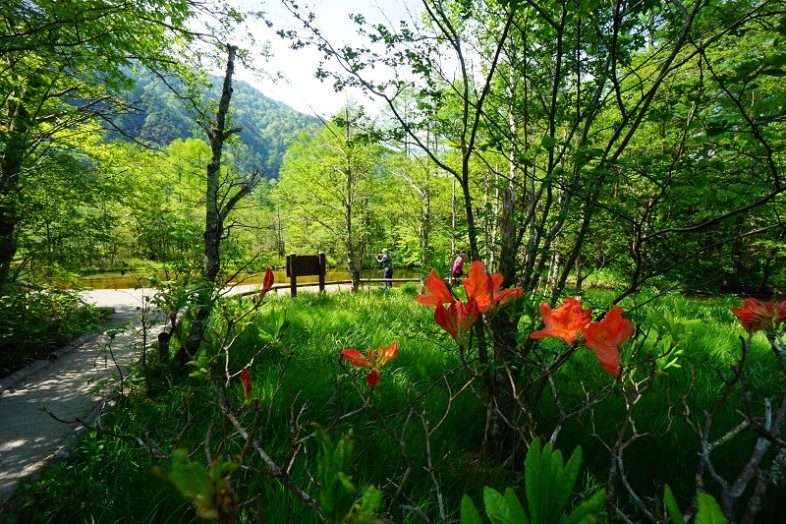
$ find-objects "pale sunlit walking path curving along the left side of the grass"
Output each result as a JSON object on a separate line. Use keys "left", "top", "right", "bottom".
{"left": 0, "top": 284, "right": 352, "bottom": 508}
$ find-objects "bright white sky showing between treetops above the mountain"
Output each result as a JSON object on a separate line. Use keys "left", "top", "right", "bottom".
{"left": 227, "top": 0, "right": 419, "bottom": 117}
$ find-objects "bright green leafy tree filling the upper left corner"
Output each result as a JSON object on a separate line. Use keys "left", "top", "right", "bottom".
{"left": 0, "top": 0, "right": 199, "bottom": 286}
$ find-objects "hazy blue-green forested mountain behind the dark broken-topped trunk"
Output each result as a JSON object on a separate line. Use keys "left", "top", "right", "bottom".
{"left": 111, "top": 72, "right": 319, "bottom": 179}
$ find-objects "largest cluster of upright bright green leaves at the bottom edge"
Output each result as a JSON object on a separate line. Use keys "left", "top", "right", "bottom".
{"left": 461, "top": 439, "right": 605, "bottom": 524}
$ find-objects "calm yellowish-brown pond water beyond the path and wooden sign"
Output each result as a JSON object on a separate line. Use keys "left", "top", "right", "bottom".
{"left": 82, "top": 269, "right": 419, "bottom": 289}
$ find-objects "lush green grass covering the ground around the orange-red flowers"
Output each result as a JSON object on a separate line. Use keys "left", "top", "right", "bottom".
{"left": 7, "top": 291, "right": 786, "bottom": 522}
